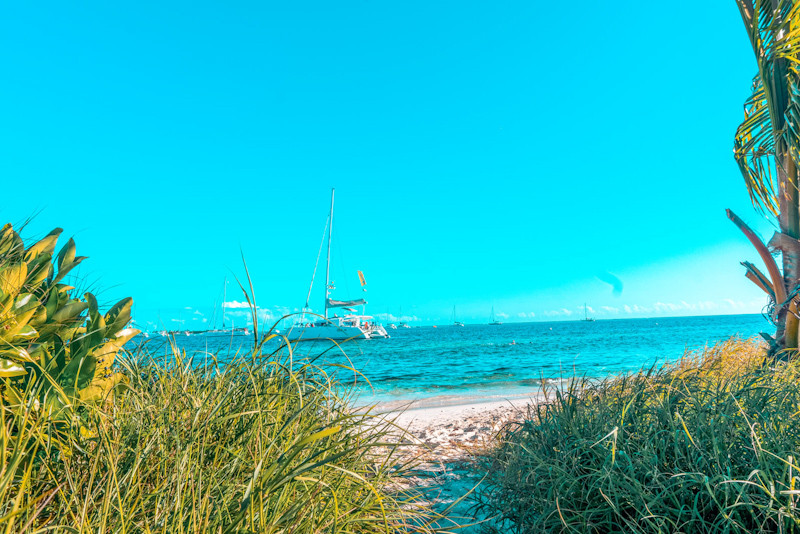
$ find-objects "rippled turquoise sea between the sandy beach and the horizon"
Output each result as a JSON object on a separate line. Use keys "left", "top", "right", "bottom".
{"left": 142, "top": 315, "right": 773, "bottom": 405}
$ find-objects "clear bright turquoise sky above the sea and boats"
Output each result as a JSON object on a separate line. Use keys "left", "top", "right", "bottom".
{"left": 0, "top": 0, "right": 773, "bottom": 328}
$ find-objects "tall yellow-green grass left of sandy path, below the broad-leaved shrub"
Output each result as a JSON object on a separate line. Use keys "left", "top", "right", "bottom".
{"left": 0, "top": 338, "right": 432, "bottom": 534}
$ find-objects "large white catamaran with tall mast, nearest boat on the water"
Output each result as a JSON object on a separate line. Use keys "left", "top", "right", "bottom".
{"left": 286, "top": 189, "right": 389, "bottom": 341}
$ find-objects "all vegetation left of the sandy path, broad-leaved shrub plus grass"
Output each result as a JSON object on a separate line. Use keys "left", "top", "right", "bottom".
{"left": 0, "top": 226, "right": 436, "bottom": 534}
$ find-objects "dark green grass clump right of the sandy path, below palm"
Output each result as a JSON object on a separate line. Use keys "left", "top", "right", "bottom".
{"left": 478, "top": 340, "right": 800, "bottom": 533}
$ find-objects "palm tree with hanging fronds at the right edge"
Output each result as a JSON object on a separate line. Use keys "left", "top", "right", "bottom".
{"left": 727, "top": 0, "right": 800, "bottom": 356}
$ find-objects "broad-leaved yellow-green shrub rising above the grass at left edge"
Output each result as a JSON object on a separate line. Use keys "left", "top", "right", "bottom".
{"left": 0, "top": 224, "right": 138, "bottom": 441}
